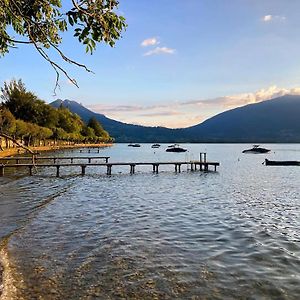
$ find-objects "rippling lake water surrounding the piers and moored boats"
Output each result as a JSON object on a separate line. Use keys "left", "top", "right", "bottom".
{"left": 0, "top": 144, "right": 300, "bottom": 300}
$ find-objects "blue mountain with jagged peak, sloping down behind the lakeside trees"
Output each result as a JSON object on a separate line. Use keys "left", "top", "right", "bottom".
{"left": 50, "top": 99, "right": 184, "bottom": 143}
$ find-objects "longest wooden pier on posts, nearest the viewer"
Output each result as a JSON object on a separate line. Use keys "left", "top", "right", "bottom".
{"left": 0, "top": 157, "right": 220, "bottom": 177}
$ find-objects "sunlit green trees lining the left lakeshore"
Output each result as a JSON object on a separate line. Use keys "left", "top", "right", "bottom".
{"left": 0, "top": 80, "right": 113, "bottom": 151}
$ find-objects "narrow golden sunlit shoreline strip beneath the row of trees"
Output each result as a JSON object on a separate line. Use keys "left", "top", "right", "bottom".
{"left": 0, "top": 143, "right": 113, "bottom": 159}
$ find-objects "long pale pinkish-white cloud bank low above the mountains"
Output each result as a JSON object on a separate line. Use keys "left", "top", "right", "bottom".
{"left": 89, "top": 85, "right": 300, "bottom": 128}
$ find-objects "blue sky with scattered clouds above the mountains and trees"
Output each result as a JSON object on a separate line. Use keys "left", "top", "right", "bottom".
{"left": 0, "top": 0, "right": 300, "bottom": 128}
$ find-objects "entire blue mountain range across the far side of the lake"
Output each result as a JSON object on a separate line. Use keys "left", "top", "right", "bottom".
{"left": 50, "top": 95, "right": 300, "bottom": 143}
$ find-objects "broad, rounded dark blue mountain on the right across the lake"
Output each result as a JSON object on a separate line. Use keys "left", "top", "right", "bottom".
{"left": 184, "top": 95, "right": 300, "bottom": 143}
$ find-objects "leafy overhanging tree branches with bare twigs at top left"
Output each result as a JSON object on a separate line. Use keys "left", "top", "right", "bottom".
{"left": 0, "top": 0, "right": 127, "bottom": 87}
